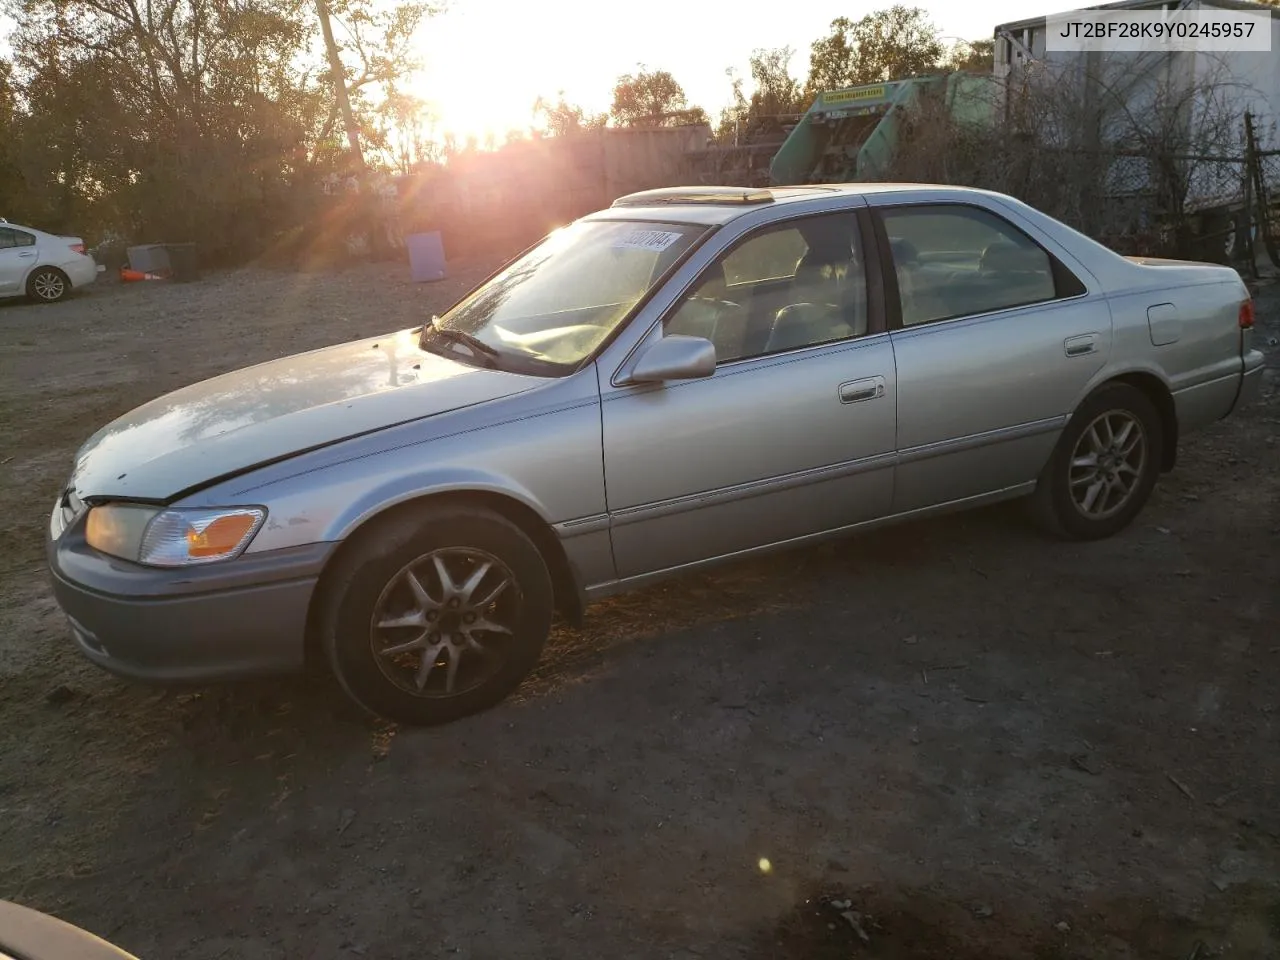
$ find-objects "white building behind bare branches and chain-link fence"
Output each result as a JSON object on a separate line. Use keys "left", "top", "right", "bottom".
{"left": 995, "top": 0, "right": 1280, "bottom": 259}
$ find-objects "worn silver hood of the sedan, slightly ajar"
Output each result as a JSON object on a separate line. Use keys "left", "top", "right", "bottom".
{"left": 72, "top": 329, "right": 545, "bottom": 500}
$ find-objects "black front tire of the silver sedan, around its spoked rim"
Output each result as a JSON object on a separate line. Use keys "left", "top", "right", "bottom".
{"left": 319, "top": 506, "right": 553, "bottom": 726}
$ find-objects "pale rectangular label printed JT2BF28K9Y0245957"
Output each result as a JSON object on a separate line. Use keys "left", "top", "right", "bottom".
{"left": 1044, "top": 8, "right": 1271, "bottom": 54}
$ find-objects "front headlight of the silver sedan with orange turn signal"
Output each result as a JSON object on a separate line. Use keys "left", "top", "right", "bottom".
{"left": 84, "top": 503, "right": 266, "bottom": 567}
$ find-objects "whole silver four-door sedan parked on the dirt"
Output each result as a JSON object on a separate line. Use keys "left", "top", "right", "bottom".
{"left": 49, "top": 184, "right": 1262, "bottom": 723}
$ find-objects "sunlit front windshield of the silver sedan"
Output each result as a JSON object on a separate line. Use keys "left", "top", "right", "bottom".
{"left": 424, "top": 220, "right": 705, "bottom": 374}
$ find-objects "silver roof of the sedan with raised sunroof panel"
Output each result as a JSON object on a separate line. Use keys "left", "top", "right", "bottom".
{"left": 582, "top": 183, "right": 1008, "bottom": 227}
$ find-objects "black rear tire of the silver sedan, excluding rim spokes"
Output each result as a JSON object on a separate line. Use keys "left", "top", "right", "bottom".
{"left": 1030, "top": 383, "right": 1165, "bottom": 540}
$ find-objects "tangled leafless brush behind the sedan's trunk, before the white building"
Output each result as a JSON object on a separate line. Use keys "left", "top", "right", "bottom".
{"left": 891, "top": 54, "right": 1244, "bottom": 252}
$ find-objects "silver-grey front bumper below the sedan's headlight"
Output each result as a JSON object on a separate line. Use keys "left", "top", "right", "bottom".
{"left": 47, "top": 517, "right": 334, "bottom": 681}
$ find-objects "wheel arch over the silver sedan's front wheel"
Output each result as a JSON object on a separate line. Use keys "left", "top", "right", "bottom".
{"left": 306, "top": 489, "right": 586, "bottom": 658}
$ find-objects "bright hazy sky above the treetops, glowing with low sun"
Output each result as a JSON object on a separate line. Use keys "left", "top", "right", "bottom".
{"left": 411, "top": 0, "right": 1049, "bottom": 141}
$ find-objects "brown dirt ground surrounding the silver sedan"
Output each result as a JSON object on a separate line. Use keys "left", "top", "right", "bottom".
{"left": 0, "top": 264, "right": 1280, "bottom": 960}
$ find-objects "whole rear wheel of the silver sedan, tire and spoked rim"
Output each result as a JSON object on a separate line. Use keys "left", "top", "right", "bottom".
{"left": 1032, "top": 384, "right": 1164, "bottom": 540}
